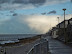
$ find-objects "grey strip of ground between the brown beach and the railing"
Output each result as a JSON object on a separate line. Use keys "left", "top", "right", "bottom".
{"left": 0, "top": 39, "right": 40, "bottom": 54}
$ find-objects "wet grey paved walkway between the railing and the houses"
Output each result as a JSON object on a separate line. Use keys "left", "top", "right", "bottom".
{"left": 47, "top": 36, "right": 72, "bottom": 54}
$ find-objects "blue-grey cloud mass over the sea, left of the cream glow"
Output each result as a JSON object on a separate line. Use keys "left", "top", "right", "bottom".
{"left": 0, "top": 15, "right": 37, "bottom": 34}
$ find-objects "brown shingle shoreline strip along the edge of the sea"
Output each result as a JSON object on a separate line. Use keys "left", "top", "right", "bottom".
{"left": 0, "top": 35, "right": 41, "bottom": 47}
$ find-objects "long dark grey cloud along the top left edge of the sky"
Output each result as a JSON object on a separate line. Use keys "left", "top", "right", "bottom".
{"left": 0, "top": 0, "right": 46, "bottom": 5}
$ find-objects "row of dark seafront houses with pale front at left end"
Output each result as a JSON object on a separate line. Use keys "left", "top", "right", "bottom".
{"left": 52, "top": 18, "right": 72, "bottom": 42}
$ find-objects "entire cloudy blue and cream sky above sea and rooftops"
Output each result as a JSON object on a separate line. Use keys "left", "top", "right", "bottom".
{"left": 0, "top": 0, "right": 72, "bottom": 34}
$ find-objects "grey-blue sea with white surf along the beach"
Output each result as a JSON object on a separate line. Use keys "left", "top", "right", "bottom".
{"left": 0, "top": 34, "right": 37, "bottom": 44}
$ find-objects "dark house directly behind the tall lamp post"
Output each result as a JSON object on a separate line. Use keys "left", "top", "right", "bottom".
{"left": 56, "top": 20, "right": 69, "bottom": 41}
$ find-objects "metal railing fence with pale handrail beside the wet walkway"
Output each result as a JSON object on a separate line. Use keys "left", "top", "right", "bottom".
{"left": 27, "top": 39, "right": 49, "bottom": 54}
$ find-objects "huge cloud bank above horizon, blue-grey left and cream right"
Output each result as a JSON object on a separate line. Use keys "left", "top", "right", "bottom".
{"left": 0, "top": 14, "right": 72, "bottom": 34}
